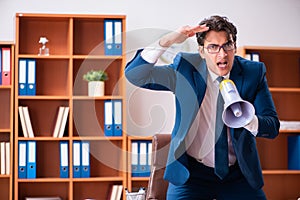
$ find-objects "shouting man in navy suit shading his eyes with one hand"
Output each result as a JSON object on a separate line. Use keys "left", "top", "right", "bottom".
{"left": 125, "top": 16, "right": 280, "bottom": 200}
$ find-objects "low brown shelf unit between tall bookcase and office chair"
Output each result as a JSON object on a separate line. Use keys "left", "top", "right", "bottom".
{"left": 127, "top": 136, "right": 152, "bottom": 192}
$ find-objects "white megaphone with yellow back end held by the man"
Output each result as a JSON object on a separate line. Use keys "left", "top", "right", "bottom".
{"left": 220, "top": 79, "right": 255, "bottom": 128}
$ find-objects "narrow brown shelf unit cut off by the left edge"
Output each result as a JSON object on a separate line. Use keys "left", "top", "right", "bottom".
{"left": 0, "top": 41, "right": 15, "bottom": 200}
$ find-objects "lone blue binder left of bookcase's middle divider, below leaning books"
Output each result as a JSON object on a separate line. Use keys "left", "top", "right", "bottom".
{"left": 59, "top": 141, "right": 69, "bottom": 178}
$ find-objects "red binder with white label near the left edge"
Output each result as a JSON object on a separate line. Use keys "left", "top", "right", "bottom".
{"left": 2, "top": 47, "right": 11, "bottom": 85}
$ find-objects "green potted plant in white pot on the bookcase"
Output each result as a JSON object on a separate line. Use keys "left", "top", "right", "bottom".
{"left": 83, "top": 69, "right": 108, "bottom": 96}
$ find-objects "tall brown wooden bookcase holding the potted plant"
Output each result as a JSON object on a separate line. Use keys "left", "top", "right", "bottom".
{"left": 14, "top": 13, "right": 127, "bottom": 200}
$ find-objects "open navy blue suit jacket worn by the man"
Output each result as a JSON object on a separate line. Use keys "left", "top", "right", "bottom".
{"left": 125, "top": 50, "right": 280, "bottom": 189}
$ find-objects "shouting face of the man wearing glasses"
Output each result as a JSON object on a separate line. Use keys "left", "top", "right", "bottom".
{"left": 199, "top": 31, "right": 236, "bottom": 76}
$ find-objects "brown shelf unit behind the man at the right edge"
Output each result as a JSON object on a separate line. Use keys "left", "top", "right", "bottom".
{"left": 238, "top": 46, "right": 300, "bottom": 199}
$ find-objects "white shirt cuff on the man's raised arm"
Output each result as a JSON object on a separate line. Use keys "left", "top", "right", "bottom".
{"left": 141, "top": 41, "right": 168, "bottom": 63}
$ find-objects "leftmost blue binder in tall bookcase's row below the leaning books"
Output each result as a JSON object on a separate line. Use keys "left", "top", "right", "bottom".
{"left": 18, "top": 141, "right": 27, "bottom": 178}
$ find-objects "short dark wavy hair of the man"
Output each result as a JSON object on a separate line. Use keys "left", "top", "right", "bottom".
{"left": 196, "top": 15, "right": 237, "bottom": 46}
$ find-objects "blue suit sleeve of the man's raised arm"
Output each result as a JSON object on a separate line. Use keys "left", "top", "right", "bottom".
{"left": 125, "top": 49, "right": 176, "bottom": 91}
